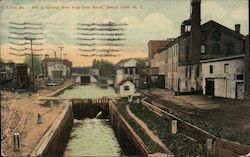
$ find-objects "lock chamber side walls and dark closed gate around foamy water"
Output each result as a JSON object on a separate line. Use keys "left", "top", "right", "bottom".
{"left": 31, "top": 98, "right": 170, "bottom": 156}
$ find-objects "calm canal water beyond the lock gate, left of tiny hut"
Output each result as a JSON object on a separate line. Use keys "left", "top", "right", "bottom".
{"left": 58, "top": 83, "right": 119, "bottom": 99}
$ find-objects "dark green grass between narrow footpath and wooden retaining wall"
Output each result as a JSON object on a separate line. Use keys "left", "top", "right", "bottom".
{"left": 129, "top": 100, "right": 219, "bottom": 157}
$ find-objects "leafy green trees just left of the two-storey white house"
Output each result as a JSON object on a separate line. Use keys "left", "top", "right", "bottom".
{"left": 92, "top": 59, "right": 115, "bottom": 77}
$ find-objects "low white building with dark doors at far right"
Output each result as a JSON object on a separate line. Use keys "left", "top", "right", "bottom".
{"left": 201, "top": 54, "right": 245, "bottom": 99}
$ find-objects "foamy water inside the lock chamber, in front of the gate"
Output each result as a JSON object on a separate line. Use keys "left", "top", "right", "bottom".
{"left": 64, "top": 119, "right": 121, "bottom": 157}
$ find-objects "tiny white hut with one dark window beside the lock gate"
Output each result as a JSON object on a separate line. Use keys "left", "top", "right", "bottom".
{"left": 118, "top": 79, "right": 136, "bottom": 96}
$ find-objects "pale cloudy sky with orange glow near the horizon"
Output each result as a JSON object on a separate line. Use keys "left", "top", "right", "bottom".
{"left": 0, "top": 0, "right": 249, "bottom": 66}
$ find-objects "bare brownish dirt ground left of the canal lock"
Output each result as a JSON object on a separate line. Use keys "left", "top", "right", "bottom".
{"left": 1, "top": 81, "right": 73, "bottom": 156}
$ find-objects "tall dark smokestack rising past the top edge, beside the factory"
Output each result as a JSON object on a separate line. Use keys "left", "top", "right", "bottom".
{"left": 190, "top": 0, "right": 201, "bottom": 60}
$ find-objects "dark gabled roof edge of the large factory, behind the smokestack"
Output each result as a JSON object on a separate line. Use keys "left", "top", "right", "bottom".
{"left": 158, "top": 20, "right": 245, "bottom": 53}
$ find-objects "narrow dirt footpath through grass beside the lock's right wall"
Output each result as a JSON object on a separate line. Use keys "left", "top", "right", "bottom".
{"left": 126, "top": 105, "right": 170, "bottom": 152}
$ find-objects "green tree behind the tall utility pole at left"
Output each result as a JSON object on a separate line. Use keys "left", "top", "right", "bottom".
{"left": 24, "top": 55, "right": 42, "bottom": 77}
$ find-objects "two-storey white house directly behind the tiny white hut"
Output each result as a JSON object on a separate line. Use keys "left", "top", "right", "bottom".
{"left": 115, "top": 58, "right": 139, "bottom": 89}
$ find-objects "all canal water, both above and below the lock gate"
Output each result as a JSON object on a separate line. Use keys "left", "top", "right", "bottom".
{"left": 61, "top": 83, "right": 122, "bottom": 157}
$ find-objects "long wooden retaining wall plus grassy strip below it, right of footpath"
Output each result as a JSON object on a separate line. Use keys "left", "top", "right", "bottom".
{"left": 140, "top": 100, "right": 250, "bottom": 157}
